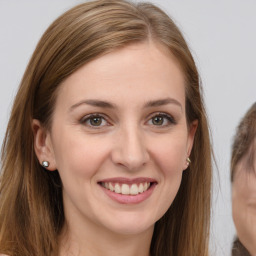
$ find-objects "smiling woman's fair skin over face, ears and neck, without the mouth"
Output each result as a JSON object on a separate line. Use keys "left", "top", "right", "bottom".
{"left": 33, "top": 42, "right": 197, "bottom": 256}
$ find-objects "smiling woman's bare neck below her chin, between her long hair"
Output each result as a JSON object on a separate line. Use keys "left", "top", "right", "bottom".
{"left": 59, "top": 218, "right": 153, "bottom": 256}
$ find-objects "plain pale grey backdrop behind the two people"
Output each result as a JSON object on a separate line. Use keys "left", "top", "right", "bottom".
{"left": 0, "top": 0, "right": 256, "bottom": 256}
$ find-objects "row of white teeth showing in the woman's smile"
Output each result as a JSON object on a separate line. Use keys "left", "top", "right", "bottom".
{"left": 102, "top": 182, "right": 150, "bottom": 195}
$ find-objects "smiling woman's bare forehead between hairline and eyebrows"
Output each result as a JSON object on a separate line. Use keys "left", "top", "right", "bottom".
{"left": 55, "top": 42, "right": 185, "bottom": 109}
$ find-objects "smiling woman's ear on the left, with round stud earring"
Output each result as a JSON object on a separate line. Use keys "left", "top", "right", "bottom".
{"left": 32, "top": 119, "right": 56, "bottom": 171}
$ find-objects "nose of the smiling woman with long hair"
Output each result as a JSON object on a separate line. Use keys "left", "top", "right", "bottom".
{"left": 112, "top": 127, "right": 150, "bottom": 171}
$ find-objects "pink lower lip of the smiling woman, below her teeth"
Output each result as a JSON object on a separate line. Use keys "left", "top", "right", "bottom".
{"left": 100, "top": 183, "right": 156, "bottom": 204}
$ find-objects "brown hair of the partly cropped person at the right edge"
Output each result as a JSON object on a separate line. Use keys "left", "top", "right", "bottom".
{"left": 231, "top": 102, "right": 256, "bottom": 256}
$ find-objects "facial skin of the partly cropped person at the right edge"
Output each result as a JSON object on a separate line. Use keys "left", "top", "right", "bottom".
{"left": 232, "top": 147, "right": 256, "bottom": 256}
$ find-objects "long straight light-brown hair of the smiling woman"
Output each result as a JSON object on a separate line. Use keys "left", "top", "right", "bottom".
{"left": 0, "top": 0, "right": 211, "bottom": 256}
